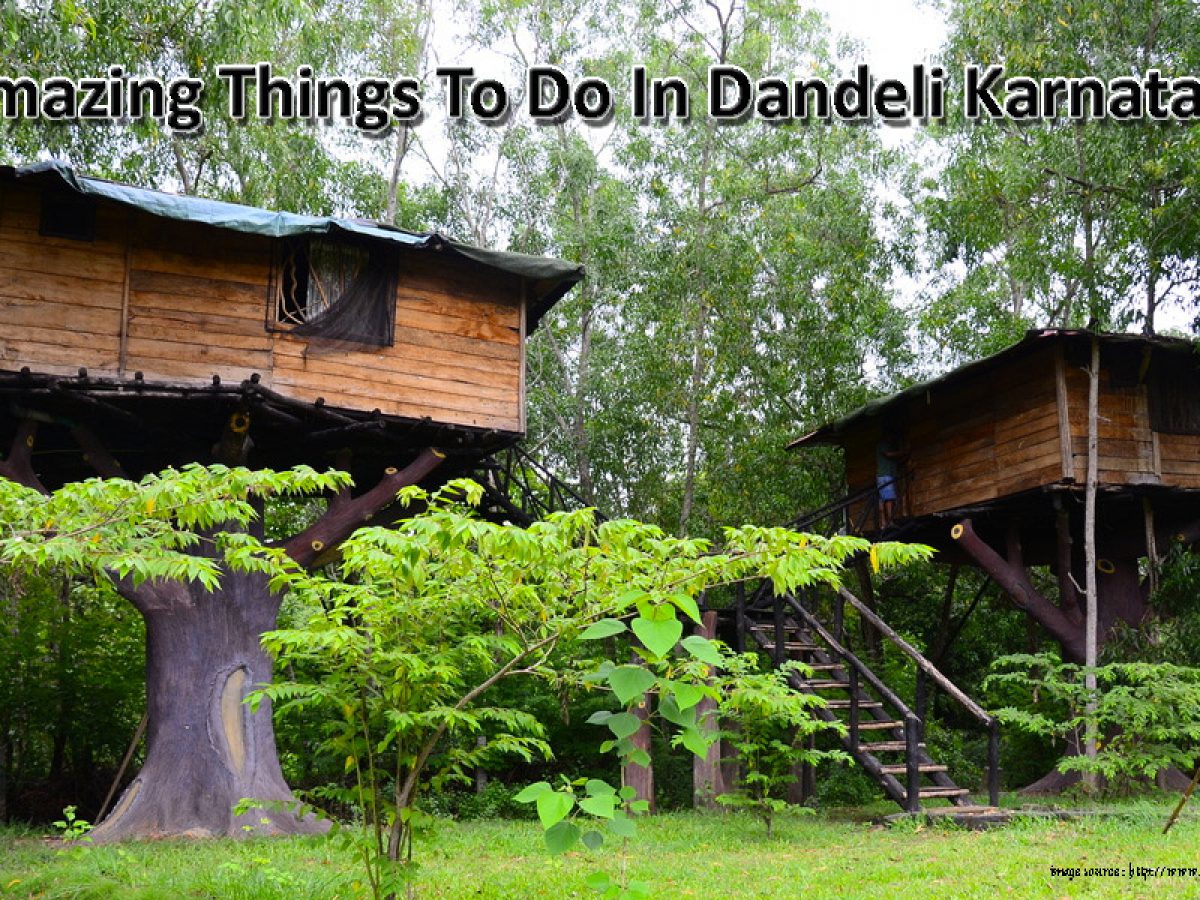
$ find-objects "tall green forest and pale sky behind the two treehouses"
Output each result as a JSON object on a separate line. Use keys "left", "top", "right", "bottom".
{"left": 0, "top": 0, "right": 1200, "bottom": 820}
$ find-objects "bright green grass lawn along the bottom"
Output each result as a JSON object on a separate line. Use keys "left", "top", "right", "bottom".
{"left": 0, "top": 796, "right": 1200, "bottom": 900}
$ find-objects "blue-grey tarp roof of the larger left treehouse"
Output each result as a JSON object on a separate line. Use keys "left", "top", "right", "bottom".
{"left": 0, "top": 160, "right": 583, "bottom": 331}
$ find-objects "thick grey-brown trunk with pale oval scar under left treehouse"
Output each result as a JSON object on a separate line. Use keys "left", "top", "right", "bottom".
{"left": 92, "top": 571, "right": 328, "bottom": 841}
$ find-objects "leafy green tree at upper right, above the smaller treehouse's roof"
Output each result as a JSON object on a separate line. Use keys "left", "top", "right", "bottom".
{"left": 923, "top": 0, "right": 1200, "bottom": 362}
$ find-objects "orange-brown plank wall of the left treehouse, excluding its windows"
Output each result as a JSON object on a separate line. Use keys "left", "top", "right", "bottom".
{"left": 0, "top": 184, "right": 524, "bottom": 432}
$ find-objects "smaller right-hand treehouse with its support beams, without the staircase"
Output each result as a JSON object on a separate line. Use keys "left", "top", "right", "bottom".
{"left": 791, "top": 330, "right": 1200, "bottom": 660}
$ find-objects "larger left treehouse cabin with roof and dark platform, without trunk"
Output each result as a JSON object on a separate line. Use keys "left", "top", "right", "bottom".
{"left": 0, "top": 163, "right": 582, "bottom": 494}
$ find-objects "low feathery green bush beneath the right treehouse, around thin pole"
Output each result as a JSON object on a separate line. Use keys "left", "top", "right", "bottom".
{"left": 986, "top": 654, "right": 1200, "bottom": 790}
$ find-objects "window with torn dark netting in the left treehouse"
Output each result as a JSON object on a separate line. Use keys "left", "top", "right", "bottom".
{"left": 271, "top": 239, "right": 395, "bottom": 347}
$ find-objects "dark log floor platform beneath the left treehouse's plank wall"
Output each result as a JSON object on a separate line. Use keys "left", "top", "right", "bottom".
{"left": 0, "top": 372, "right": 506, "bottom": 488}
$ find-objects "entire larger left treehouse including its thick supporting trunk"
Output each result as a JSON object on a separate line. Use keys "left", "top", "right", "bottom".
{"left": 0, "top": 163, "right": 582, "bottom": 841}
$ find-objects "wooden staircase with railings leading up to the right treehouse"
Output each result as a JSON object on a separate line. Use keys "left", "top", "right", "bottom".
{"left": 736, "top": 590, "right": 1000, "bottom": 812}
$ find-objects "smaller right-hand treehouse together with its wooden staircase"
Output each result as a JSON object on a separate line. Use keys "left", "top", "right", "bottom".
{"left": 710, "top": 330, "right": 1200, "bottom": 810}
